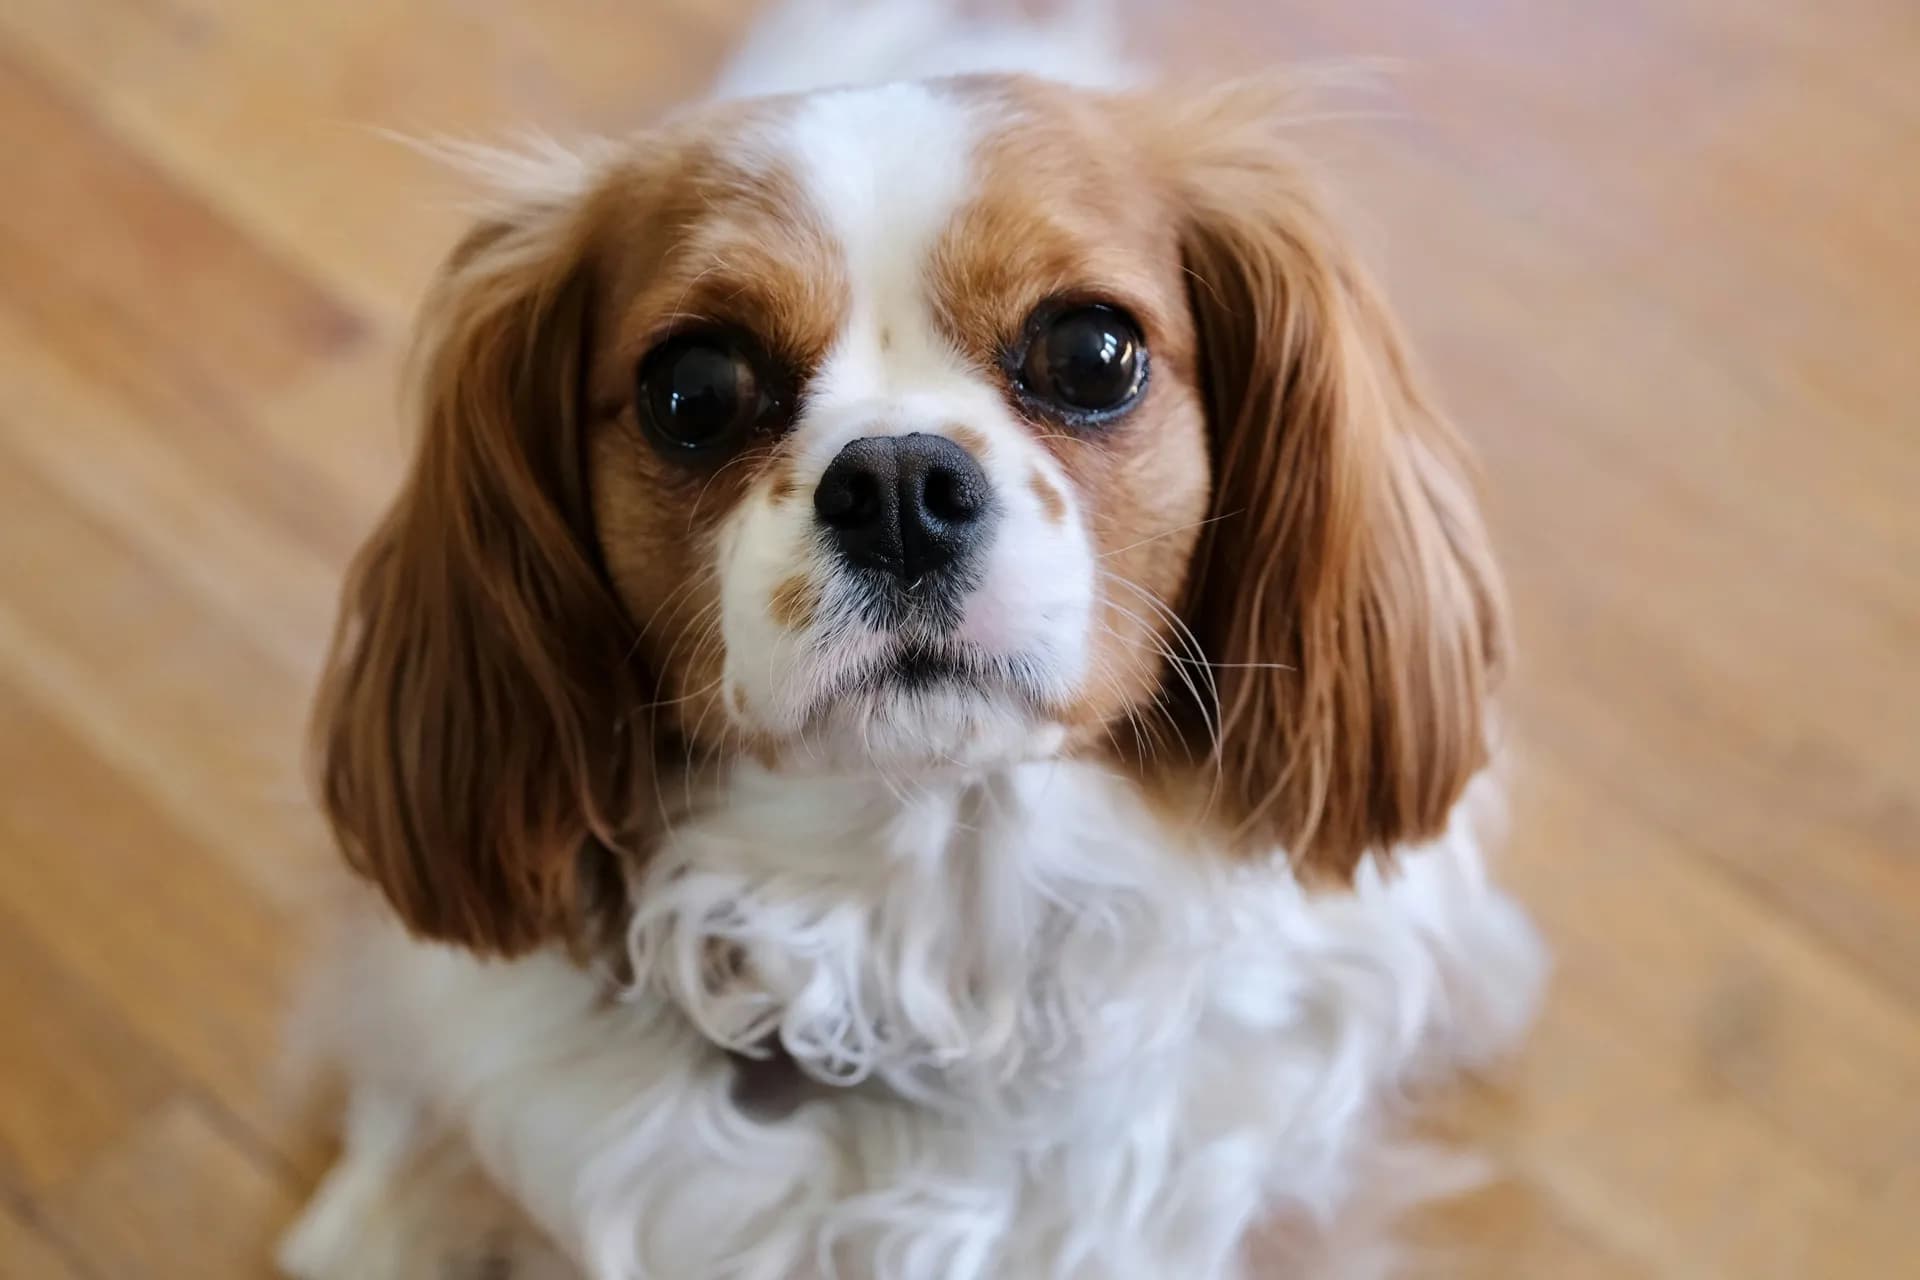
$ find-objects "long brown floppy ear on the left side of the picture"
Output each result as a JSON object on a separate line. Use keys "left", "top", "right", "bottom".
{"left": 315, "top": 160, "right": 647, "bottom": 954}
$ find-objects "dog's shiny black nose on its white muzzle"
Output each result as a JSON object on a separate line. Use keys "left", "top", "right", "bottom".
{"left": 814, "top": 432, "right": 993, "bottom": 583}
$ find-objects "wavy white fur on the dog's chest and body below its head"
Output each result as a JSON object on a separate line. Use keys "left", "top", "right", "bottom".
{"left": 288, "top": 764, "right": 1542, "bottom": 1280}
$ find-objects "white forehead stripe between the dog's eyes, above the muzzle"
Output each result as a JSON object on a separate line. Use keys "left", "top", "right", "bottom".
{"left": 780, "top": 84, "right": 979, "bottom": 405}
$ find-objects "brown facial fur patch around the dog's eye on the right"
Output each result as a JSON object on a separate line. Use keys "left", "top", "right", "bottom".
{"left": 931, "top": 81, "right": 1210, "bottom": 750}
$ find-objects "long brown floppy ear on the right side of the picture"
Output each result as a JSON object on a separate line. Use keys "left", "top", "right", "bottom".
{"left": 1173, "top": 84, "right": 1507, "bottom": 879}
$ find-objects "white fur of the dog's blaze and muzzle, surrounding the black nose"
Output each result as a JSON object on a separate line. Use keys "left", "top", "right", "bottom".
{"left": 718, "top": 84, "right": 1098, "bottom": 760}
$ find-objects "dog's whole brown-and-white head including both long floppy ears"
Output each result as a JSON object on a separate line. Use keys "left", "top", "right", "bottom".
{"left": 321, "top": 79, "right": 1500, "bottom": 950}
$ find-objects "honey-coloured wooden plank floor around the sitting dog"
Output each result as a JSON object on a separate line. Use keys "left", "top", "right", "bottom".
{"left": 0, "top": 0, "right": 1920, "bottom": 1280}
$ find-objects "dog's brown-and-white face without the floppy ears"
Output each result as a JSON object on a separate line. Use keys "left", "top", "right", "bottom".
{"left": 588, "top": 83, "right": 1210, "bottom": 773}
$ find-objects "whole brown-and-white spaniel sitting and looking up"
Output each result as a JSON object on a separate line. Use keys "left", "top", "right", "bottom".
{"left": 282, "top": 4, "right": 1544, "bottom": 1280}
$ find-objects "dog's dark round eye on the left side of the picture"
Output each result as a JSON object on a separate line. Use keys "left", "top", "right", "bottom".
{"left": 636, "top": 334, "right": 774, "bottom": 451}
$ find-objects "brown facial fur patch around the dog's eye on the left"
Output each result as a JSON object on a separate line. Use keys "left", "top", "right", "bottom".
{"left": 586, "top": 104, "right": 847, "bottom": 756}
